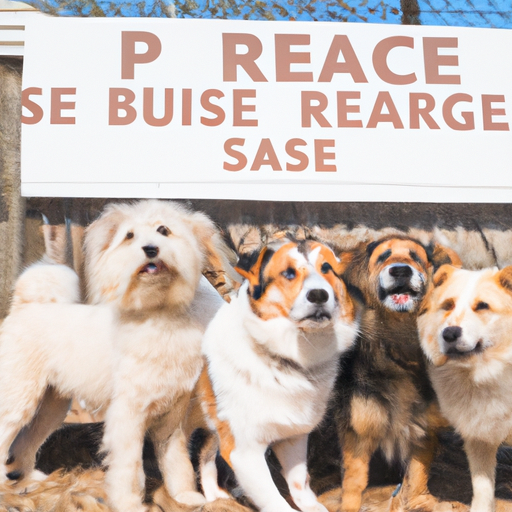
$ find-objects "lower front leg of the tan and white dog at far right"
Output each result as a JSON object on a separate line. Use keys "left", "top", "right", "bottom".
{"left": 464, "top": 439, "right": 498, "bottom": 512}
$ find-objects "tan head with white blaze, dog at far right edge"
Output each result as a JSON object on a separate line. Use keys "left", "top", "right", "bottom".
{"left": 418, "top": 265, "right": 512, "bottom": 366}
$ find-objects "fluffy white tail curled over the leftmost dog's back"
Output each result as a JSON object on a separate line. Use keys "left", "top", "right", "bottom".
{"left": 11, "top": 260, "right": 80, "bottom": 309}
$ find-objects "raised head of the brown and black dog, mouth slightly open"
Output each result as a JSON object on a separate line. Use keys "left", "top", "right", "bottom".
{"left": 346, "top": 235, "right": 460, "bottom": 313}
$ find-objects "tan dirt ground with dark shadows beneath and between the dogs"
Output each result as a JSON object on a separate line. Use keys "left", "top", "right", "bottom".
{"left": 0, "top": 423, "right": 512, "bottom": 512}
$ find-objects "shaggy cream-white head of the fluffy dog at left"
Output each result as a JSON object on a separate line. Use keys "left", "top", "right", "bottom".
{"left": 85, "top": 200, "right": 216, "bottom": 310}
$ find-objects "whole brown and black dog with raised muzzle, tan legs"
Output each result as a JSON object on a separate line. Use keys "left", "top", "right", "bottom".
{"left": 334, "top": 236, "right": 460, "bottom": 512}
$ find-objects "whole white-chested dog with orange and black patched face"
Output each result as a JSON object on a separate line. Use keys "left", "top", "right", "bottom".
{"left": 199, "top": 241, "right": 358, "bottom": 512}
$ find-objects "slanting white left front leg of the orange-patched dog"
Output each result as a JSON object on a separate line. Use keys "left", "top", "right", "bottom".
{"left": 231, "top": 443, "right": 293, "bottom": 512}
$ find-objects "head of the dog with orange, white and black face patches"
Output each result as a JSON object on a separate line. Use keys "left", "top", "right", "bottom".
{"left": 236, "top": 241, "right": 355, "bottom": 330}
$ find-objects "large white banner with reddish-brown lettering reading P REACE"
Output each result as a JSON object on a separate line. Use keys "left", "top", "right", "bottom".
{"left": 22, "top": 16, "right": 512, "bottom": 202}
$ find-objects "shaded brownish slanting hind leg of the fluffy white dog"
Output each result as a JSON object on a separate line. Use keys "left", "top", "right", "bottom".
{"left": 7, "top": 387, "right": 71, "bottom": 479}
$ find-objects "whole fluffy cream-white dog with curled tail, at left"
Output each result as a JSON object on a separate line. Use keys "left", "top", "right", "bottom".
{"left": 0, "top": 200, "right": 223, "bottom": 512}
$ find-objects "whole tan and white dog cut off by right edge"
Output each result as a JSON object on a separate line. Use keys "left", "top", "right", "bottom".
{"left": 418, "top": 265, "right": 512, "bottom": 512}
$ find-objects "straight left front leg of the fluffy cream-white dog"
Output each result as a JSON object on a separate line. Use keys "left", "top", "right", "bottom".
{"left": 103, "top": 396, "right": 146, "bottom": 512}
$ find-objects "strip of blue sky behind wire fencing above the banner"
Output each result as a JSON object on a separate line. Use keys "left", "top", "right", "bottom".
{"left": 24, "top": 0, "right": 512, "bottom": 28}
